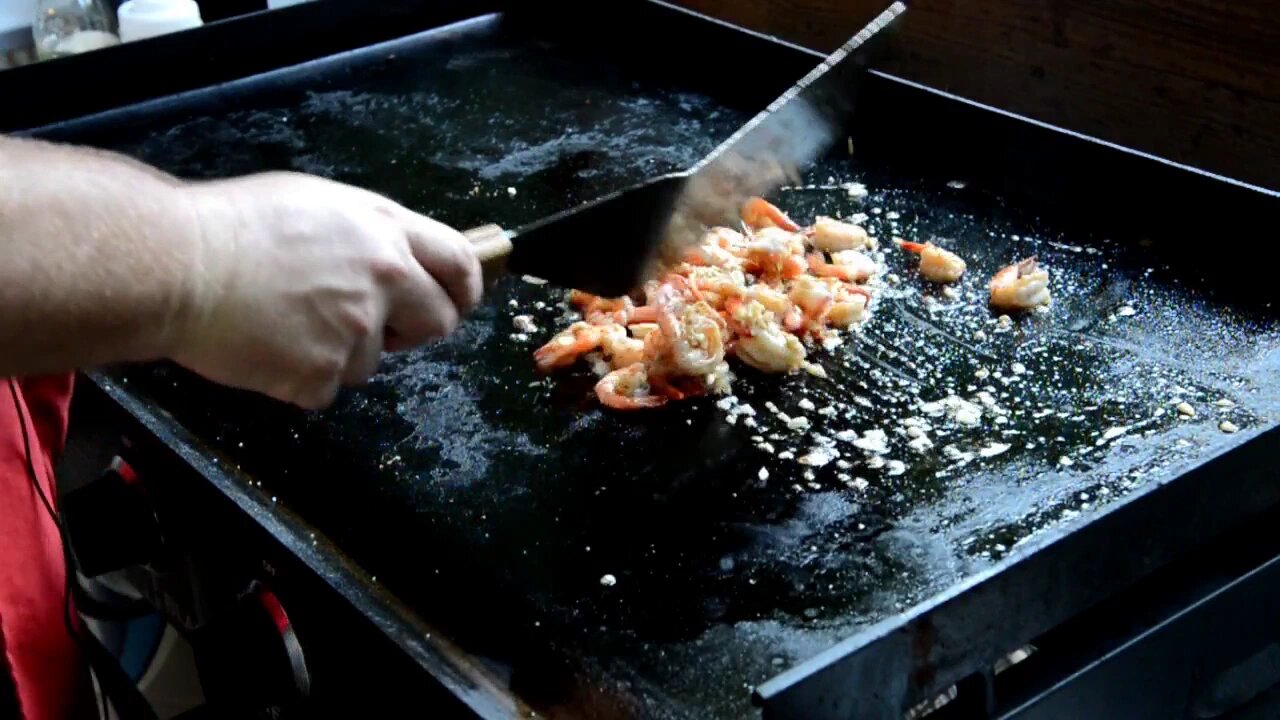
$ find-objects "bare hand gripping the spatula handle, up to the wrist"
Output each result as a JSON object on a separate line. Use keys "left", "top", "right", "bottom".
{"left": 169, "top": 173, "right": 481, "bottom": 409}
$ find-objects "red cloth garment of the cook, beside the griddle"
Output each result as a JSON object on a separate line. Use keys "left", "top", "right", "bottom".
{"left": 0, "top": 375, "right": 97, "bottom": 720}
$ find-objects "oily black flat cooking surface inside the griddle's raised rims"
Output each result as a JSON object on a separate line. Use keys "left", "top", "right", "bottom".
{"left": 27, "top": 4, "right": 1280, "bottom": 717}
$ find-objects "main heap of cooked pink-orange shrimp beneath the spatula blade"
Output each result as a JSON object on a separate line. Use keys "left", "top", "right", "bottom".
{"left": 535, "top": 197, "right": 880, "bottom": 410}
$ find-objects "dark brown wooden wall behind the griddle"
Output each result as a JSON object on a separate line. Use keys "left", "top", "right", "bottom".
{"left": 676, "top": 0, "right": 1280, "bottom": 190}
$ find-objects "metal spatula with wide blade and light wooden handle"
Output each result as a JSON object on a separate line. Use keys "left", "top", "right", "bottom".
{"left": 466, "top": 3, "right": 906, "bottom": 297}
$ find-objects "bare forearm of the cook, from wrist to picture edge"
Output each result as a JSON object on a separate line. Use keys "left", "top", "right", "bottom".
{"left": 0, "top": 137, "right": 201, "bottom": 377}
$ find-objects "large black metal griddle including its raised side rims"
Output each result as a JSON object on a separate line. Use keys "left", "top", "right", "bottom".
{"left": 12, "top": 3, "right": 1280, "bottom": 717}
